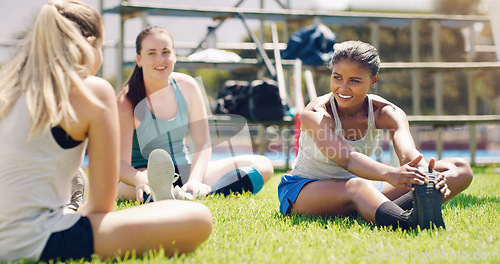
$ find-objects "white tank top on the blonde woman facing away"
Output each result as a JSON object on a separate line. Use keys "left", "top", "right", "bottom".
{"left": 0, "top": 95, "right": 86, "bottom": 263}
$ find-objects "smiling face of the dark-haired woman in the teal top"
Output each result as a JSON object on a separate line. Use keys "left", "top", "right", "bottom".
{"left": 137, "top": 32, "right": 176, "bottom": 85}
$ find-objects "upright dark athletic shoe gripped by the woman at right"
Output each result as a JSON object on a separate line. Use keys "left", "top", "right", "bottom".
{"left": 413, "top": 169, "right": 445, "bottom": 229}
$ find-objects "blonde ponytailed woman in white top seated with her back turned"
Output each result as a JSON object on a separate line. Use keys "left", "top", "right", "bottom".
{"left": 0, "top": 0, "right": 212, "bottom": 263}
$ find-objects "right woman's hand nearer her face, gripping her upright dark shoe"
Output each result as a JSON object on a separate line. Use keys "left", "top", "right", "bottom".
{"left": 386, "top": 155, "right": 428, "bottom": 191}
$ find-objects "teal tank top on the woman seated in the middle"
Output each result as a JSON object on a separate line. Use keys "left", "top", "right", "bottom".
{"left": 132, "top": 77, "right": 191, "bottom": 169}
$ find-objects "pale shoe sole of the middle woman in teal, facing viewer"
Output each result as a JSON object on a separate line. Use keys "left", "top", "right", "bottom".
{"left": 148, "top": 149, "right": 175, "bottom": 201}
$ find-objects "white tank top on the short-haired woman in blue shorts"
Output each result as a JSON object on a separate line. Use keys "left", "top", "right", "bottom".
{"left": 291, "top": 94, "right": 380, "bottom": 179}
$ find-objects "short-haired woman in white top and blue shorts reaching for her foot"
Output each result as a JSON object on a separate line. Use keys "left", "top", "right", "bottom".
{"left": 278, "top": 41, "right": 472, "bottom": 229}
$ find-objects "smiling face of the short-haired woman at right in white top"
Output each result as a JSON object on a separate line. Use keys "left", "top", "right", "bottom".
{"left": 330, "top": 59, "right": 378, "bottom": 109}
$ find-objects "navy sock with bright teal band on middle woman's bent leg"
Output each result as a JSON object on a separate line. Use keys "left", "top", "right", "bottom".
{"left": 210, "top": 166, "right": 264, "bottom": 195}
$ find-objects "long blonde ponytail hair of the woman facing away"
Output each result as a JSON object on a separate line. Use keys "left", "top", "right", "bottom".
{"left": 0, "top": 0, "right": 103, "bottom": 136}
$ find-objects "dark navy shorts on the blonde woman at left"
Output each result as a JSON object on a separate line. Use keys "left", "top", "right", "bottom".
{"left": 40, "top": 217, "right": 94, "bottom": 262}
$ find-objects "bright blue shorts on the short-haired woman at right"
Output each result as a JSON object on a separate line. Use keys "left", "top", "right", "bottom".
{"left": 278, "top": 174, "right": 383, "bottom": 215}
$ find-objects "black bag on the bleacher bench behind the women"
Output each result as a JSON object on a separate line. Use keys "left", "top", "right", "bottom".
{"left": 215, "top": 79, "right": 285, "bottom": 122}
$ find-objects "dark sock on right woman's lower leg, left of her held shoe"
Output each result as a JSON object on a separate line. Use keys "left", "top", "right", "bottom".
{"left": 375, "top": 201, "right": 411, "bottom": 229}
